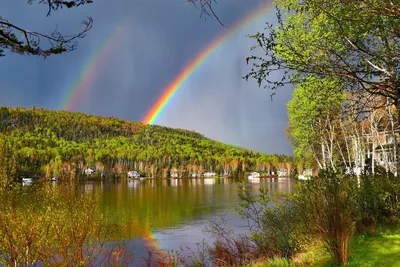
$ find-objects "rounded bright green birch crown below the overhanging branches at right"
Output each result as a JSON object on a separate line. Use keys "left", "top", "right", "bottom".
{"left": 287, "top": 76, "right": 344, "bottom": 167}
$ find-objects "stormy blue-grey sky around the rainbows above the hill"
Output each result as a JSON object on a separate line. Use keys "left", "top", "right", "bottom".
{"left": 0, "top": 0, "right": 293, "bottom": 155}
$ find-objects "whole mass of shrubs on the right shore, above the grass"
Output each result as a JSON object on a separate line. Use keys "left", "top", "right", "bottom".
{"left": 190, "top": 169, "right": 400, "bottom": 266}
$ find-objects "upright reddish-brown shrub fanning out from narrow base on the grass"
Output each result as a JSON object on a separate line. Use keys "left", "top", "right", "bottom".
{"left": 295, "top": 169, "right": 359, "bottom": 264}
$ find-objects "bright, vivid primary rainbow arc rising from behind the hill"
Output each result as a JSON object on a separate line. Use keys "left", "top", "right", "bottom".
{"left": 142, "top": 1, "right": 271, "bottom": 124}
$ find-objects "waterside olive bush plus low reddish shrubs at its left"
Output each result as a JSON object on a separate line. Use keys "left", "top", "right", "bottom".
{"left": 203, "top": 186, "right": 309, "bottom": 266}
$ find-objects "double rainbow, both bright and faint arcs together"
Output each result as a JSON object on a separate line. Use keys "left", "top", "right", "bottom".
{"left": 61, "top": 0, "right": 271, "bottom": 119}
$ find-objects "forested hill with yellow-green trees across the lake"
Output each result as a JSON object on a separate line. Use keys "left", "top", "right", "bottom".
{"left": 0, "top": 107, "right": 290, "bottom": 179}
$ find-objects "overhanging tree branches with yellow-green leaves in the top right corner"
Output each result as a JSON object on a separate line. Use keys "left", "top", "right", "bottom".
{"left": 245, "top": 0, "right": 400, "bottom": 112}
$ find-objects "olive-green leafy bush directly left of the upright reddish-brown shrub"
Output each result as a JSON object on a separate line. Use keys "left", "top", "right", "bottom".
{"left": 237, "top": 187, "right": 308, "bottom": 258}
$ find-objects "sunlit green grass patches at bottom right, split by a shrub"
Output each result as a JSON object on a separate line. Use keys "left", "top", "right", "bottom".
{"left": 250, "top": 228, "right": 400, "bottom": 267}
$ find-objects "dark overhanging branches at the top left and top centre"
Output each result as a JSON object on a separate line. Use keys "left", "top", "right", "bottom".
{"left": 0, "top": 0, "right": 223, "bottom": 57}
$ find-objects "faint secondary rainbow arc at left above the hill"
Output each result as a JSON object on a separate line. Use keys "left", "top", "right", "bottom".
{"left": 61, "top": 19, "right": 131, "bottom": 111}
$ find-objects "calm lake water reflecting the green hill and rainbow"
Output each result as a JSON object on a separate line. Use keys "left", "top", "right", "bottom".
{"left": 76, "top": 178, "right": 294, "bottom": 264}
